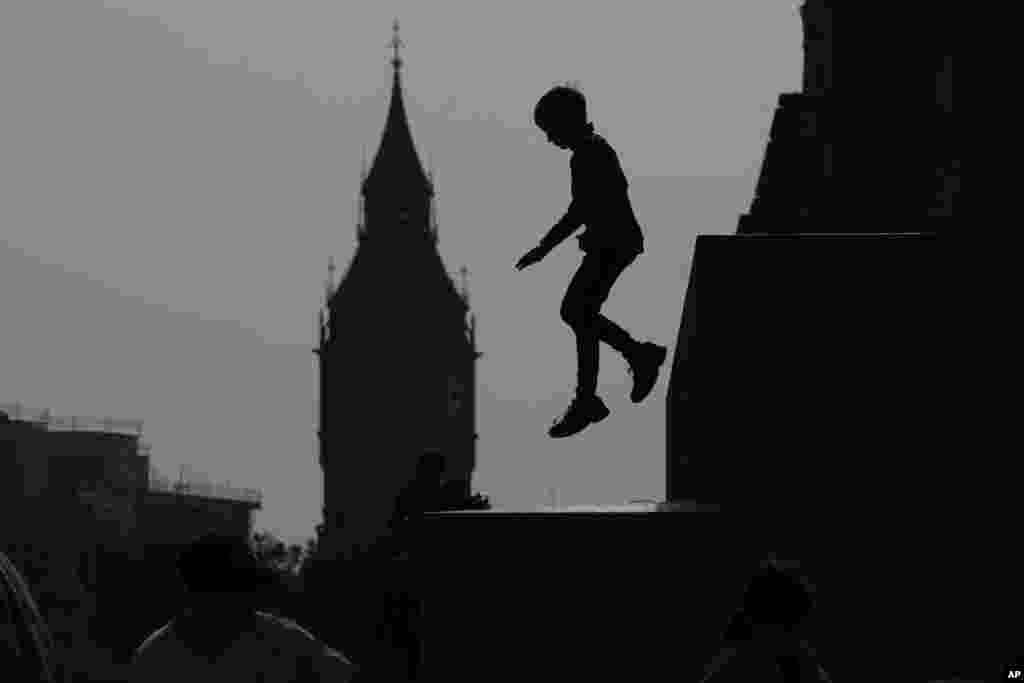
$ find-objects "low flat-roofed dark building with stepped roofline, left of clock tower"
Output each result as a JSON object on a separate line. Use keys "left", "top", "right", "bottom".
{"left": 0, "top": 401, "right": 261, "bottom": 553}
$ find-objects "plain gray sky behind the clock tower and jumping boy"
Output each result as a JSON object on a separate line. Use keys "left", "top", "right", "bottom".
{"left": 0, "top": 0, "right": 802, "bottom": 540}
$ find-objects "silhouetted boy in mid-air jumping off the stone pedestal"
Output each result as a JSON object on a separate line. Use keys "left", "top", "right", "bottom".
{"left": 516, "top": 86, "right": 667, "bottom": 438}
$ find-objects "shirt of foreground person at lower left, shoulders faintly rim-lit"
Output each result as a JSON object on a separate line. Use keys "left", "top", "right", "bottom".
{"left": 131, "top": 611, "right": 358, "bottom": 683}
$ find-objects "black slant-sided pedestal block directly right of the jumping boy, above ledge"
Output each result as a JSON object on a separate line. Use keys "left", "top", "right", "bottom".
{"left": 667, "top": 234, "right": 942, "bottom": 513}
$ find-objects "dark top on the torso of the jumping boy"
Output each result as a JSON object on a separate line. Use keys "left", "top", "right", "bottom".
{"left": 569, "top": 133, "right": 644, "bottom": 253}
